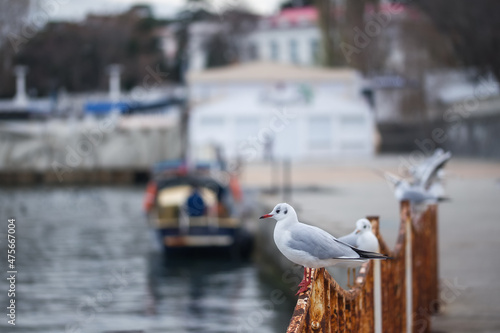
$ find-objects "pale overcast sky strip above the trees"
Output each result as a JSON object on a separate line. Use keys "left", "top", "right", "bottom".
{"left": 41, "top": 0, "right": 283, "bottom": 20}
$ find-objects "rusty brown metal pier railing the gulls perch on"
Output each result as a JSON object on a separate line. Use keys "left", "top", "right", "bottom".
{"left": 287, "top": 202, "right": 439, "bottom": 333}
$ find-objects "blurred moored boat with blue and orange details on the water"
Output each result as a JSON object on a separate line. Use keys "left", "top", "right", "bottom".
{"left": 144, "top": 161, "right": 252, "bottom": 258}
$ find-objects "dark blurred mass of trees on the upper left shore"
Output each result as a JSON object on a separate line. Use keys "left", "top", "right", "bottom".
{"left": 0, "top": 6, "right": 165, "bottom": 96}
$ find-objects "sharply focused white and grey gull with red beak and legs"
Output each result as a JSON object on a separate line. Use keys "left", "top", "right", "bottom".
{"left": 260, "top": 203, "right": 387, "bottom": 295}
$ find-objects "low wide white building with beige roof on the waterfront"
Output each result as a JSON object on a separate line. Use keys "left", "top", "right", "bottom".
{"left": 188, "top": 62, "right": 375, "bottom": 161}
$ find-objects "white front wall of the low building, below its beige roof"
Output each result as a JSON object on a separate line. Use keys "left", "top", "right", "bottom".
{"left": 190, "top": 83, "right": 374, "bottom": 161}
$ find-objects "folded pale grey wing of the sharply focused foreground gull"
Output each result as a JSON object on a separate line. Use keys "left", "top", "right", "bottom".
{"left": 287, "top": 223, "right": 360, "bottom": 260}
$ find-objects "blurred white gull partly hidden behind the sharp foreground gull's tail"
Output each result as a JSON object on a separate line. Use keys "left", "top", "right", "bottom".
{"left": 339, "top": 219, "right": 379, "bottom": 287}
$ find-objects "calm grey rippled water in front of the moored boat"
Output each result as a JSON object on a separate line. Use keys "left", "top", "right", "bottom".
{"left": 0, "top": 187, "right": 293, "bottom": 333}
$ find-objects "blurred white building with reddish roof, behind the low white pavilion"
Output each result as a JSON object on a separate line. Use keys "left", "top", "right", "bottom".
{"left": 157, "top": 6, "right": 322, "bottom": 72}
